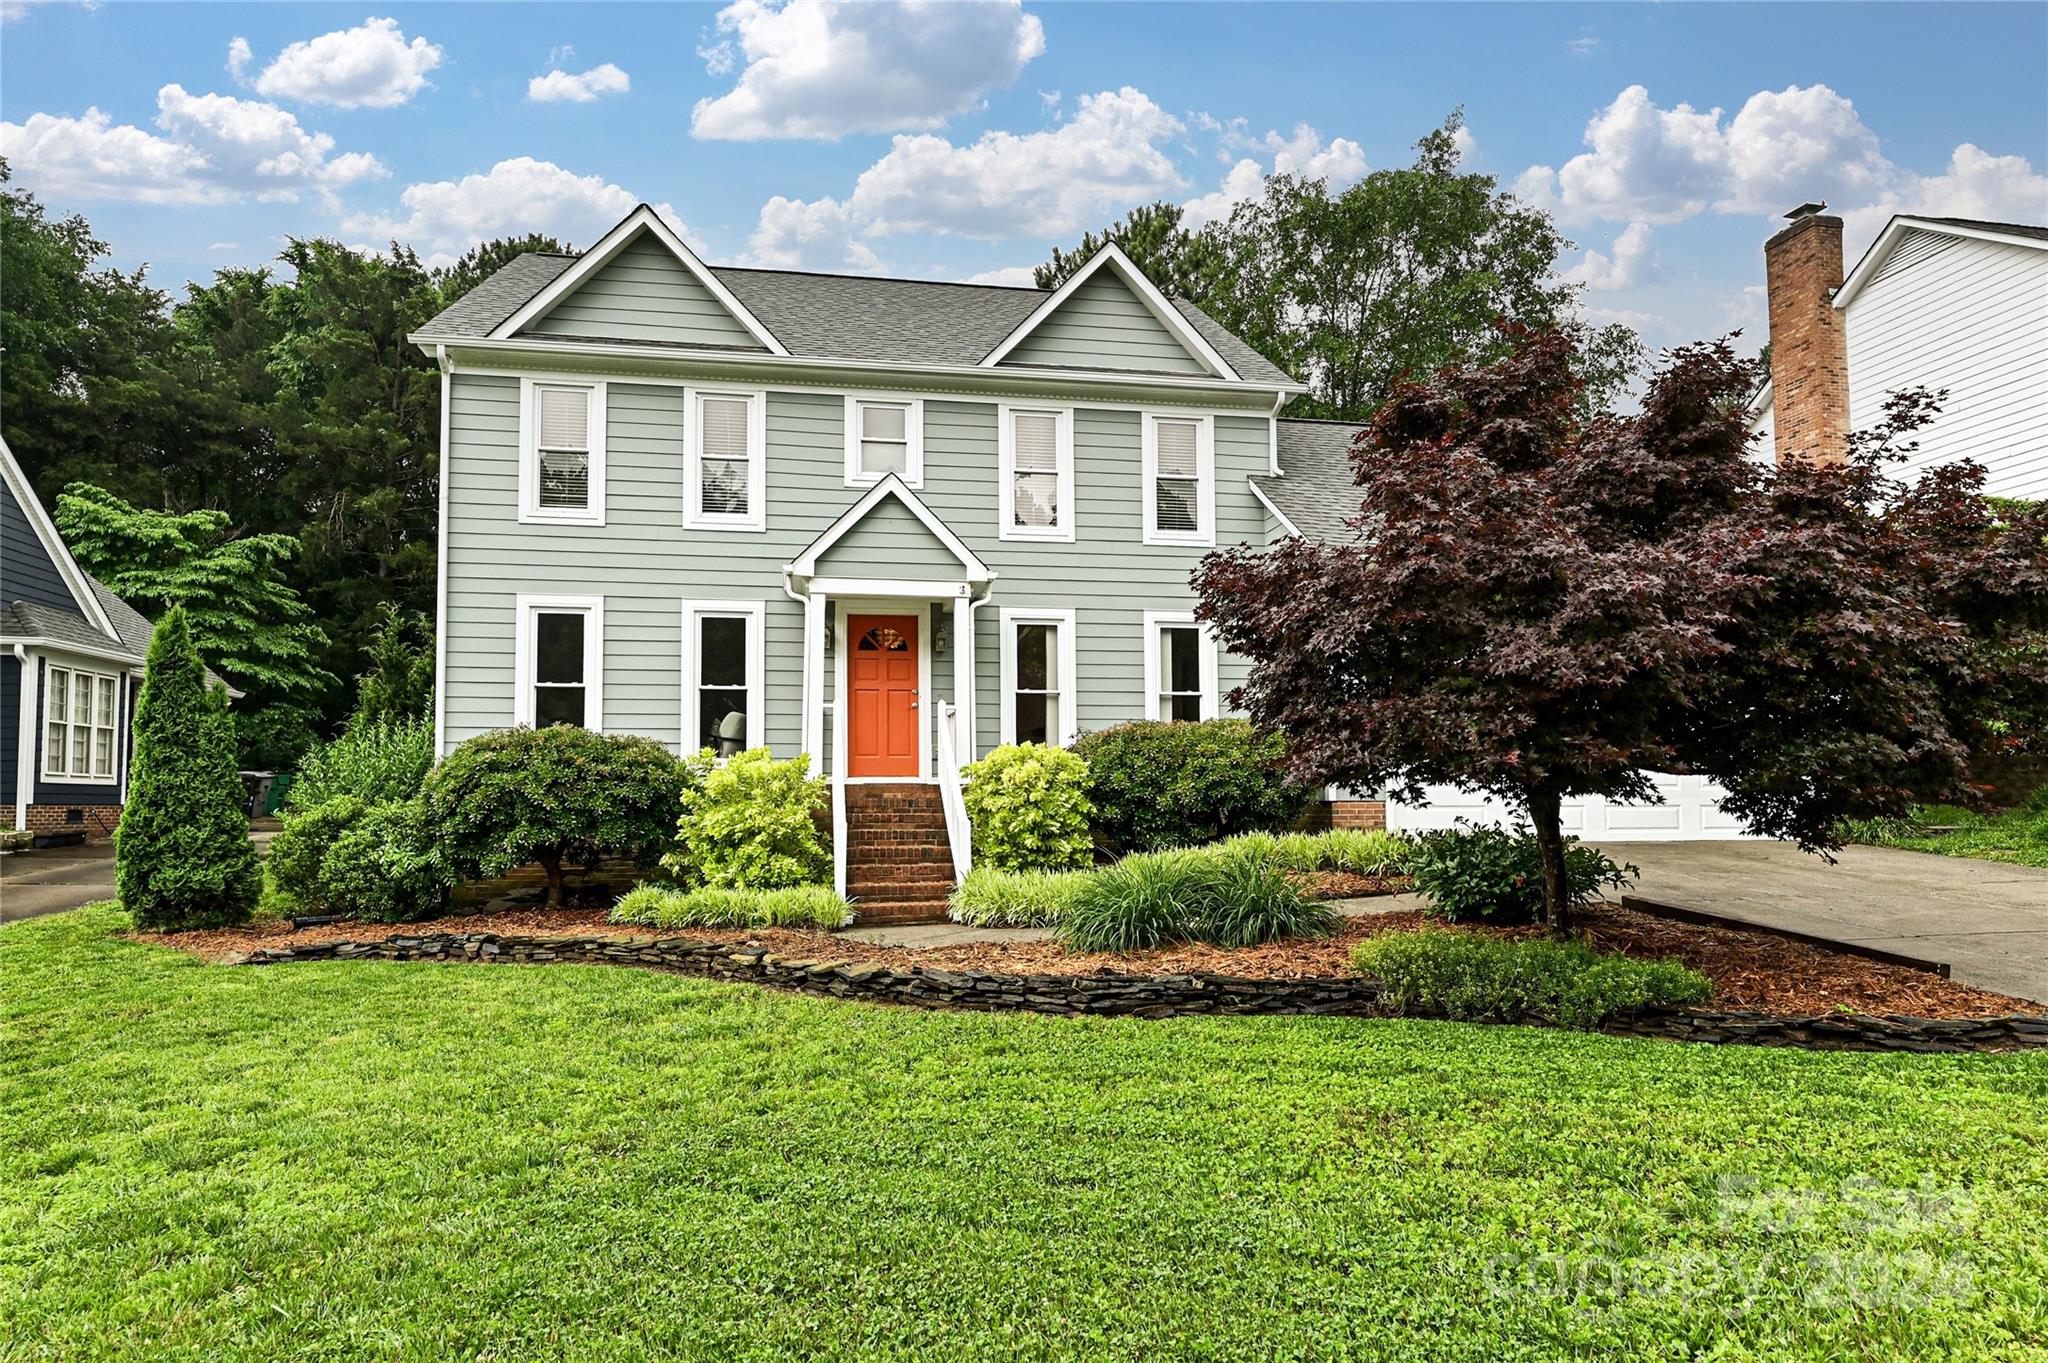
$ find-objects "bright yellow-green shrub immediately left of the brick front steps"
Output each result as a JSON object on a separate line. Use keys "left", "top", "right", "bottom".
{"left": 662, "top": 747, "right": 831, "bottom": 890}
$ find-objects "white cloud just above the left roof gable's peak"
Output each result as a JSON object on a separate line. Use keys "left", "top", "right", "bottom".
{"left": 342, "top": 156, "right": 700, "bottom": 266}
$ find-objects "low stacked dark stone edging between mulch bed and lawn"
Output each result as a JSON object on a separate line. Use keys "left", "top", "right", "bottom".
{"left": 233, "top": 933, "right": 2048, "bottom": 1052}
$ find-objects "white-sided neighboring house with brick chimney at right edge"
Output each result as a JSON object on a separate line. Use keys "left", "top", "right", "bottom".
{"left": 1751, "top": 205, "right": 2048, "bottom": 499}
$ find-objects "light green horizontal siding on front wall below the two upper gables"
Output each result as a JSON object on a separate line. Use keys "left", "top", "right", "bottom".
{"left": 442, "top": 372, "right": 1268, "bottom": 755}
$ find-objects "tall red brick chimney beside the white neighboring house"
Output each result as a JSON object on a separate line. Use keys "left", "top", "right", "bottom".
{"left": 1763, "top": 203, "right": 1849, "bottom": 463}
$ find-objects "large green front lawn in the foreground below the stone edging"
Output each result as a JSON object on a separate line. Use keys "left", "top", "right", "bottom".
{"left": 0, "top": 909, "right": 2048, "bottom": 1363}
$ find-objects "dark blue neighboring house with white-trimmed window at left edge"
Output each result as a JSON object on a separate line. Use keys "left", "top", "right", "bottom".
{"left": 0, "top": 440, "right": 150, "bottom": 839}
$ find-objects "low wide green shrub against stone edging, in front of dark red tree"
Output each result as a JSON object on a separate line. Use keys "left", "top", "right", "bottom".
{"left": 1352, "top": 927, "right": 1714, "bottom": 1027}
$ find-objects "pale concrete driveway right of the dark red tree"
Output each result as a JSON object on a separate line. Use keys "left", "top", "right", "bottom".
{"left": 1599, "top": 843, "right": 2048, "bottom": 1003}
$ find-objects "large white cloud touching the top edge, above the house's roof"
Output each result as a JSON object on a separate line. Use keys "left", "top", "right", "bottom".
{"left": 690, "top": 0, "right": 1044, "bottom": 141}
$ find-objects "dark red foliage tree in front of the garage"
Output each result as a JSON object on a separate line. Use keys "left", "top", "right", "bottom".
{"left": 1196, "top": 329, "right": 2048, "bottom": 933}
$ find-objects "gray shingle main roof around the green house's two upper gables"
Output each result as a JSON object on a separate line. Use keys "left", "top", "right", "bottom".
{"left": 420, "top": 254, "right": 1292, "bottom": 383}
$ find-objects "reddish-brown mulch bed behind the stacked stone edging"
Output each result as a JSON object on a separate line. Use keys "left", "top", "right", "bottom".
{"left": 135, "top": 905, "right": 2048, "bottom": 1017}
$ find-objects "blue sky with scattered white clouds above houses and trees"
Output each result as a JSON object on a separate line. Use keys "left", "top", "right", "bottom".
{"left": 0, "top": 0, "right": 2048, "bottom": 344}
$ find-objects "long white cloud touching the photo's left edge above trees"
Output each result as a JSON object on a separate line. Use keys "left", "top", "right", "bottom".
{"left": 0, "top": 84, "right": 387, "bottom": 203}
